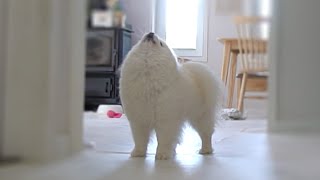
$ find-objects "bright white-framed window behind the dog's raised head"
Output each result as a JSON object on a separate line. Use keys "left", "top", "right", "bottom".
{"left": 155, "top": 0, "right": 207, "bottom": 60}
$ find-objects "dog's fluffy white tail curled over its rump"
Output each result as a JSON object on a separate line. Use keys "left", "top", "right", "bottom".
{"left": 181, "top": 62, "right": 224, "bottom": 110}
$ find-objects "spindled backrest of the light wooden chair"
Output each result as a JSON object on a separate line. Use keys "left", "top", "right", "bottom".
{"left": 233, "top": 16, "right": 268, "bottom": 73}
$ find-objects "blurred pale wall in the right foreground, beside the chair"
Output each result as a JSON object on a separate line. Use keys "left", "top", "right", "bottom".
{"left": 270, "top": 0, "right": 320, "bottom": 131}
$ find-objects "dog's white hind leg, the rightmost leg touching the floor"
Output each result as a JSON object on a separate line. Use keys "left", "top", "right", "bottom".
{"left": 189, "top": 113, "right": 214, "bottom": 154}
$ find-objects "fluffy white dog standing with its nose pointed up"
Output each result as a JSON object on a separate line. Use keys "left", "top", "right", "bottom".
{"left": 120, "top": 33, "right": 221, "bottom": 159}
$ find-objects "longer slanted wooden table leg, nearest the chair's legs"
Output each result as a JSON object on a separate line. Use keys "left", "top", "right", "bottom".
{"left": 227, "top": 53, "right": 238, "bottom": 108}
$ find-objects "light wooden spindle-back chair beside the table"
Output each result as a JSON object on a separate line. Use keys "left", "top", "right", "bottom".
{"left": 231, "top": 16, "right": 268, "bottom": 112}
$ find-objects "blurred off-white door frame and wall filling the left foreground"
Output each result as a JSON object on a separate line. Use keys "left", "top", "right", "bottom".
{"left": 0, "top": 0, "right": 85, "bottom": 161}
